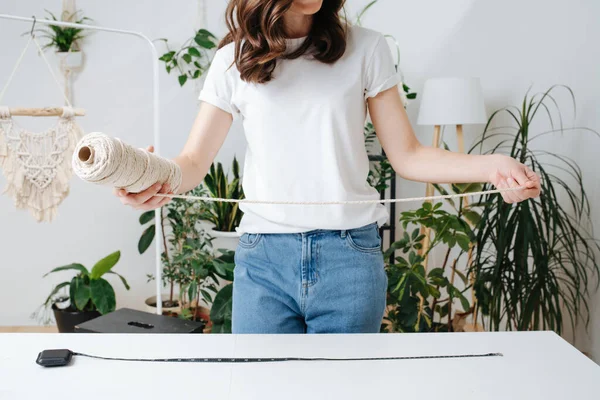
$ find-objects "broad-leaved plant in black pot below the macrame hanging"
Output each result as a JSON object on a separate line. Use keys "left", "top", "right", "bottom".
{"left": 33, "top": 251, "right": 129, "bottom": 333}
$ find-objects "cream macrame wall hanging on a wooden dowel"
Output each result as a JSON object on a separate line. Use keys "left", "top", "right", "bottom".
{"left": 0, "top": 34, "right": 85, "bottom": 222}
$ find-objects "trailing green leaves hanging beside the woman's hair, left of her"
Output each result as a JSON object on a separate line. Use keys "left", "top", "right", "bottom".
{"left": 159, "top": 29, "right": 217, "bottom": 86}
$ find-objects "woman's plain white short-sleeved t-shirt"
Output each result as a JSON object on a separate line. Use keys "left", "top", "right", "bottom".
{"left": 200, "top": 26, "right": 399, "bottom": 233}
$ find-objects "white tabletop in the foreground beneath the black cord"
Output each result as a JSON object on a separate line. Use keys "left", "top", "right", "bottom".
{"left": 0, "top": 332, "right": 600, "bottom": 400}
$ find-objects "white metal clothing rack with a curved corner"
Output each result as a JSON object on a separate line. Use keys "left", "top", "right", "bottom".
{"left": 0, "top": 14, "right": 162, "bottom": 315}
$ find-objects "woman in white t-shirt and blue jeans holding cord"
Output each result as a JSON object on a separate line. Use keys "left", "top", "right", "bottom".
{"left": 117, "top": 0, "right": 540, "bottom": 333}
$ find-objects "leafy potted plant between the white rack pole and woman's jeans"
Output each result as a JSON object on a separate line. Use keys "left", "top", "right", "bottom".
{"left": 138, "top": 186, "right": 233, "bottom": 322}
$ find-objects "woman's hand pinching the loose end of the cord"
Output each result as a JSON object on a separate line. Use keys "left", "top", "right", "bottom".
{"left": 489, "top": 155, "right": 541, "bottom": 203}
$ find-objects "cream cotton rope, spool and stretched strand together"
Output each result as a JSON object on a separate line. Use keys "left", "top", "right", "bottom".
{"left": 73, "top": 133, "right": 524, "bottom": 206}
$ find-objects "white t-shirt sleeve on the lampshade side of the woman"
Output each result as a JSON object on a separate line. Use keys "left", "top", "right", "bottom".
{"left": 365, "top": 34, "right": 400, "bottom": 100}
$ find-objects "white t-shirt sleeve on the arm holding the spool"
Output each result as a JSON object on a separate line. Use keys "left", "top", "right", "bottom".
{"left": 199, "top": 48, "right": 237, "bottom": 115}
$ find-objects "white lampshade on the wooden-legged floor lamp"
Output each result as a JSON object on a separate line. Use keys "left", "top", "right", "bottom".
{"left": 417, "top": 78, "right": 487, "bottom": 125}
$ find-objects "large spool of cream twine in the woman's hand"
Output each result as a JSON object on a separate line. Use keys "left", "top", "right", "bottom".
{"left": 72, "top": 132, "right": 181, "bottom": 193}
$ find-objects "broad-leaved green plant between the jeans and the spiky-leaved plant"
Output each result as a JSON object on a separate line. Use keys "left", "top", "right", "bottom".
{"left": 382, "top": 184, "right": 481, "bottom": 332}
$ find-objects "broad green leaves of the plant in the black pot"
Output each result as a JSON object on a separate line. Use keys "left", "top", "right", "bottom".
{"left": 42, "top": 251, "right": 129, "bottom": 314}
